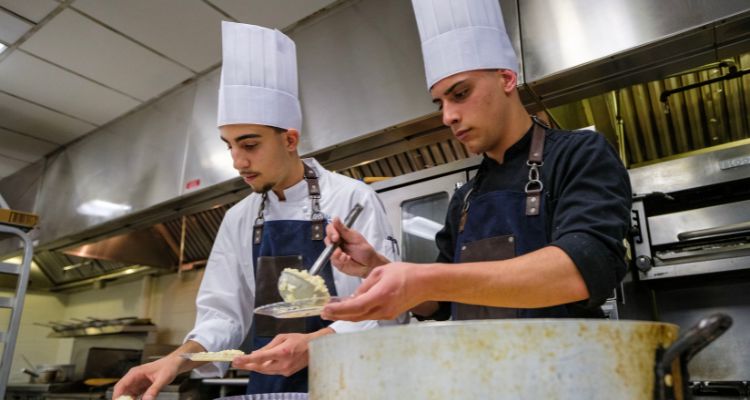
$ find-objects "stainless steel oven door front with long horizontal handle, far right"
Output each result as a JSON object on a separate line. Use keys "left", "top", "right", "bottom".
{"left": 648, "top": 200, "right": 750, "bottom": 246}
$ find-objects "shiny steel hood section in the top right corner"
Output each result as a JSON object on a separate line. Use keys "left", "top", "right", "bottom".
{"left": 519, "top": 0, "right": 750, "bottom": 106}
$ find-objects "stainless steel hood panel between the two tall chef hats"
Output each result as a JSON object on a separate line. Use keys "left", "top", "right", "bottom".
{"left": 289, "top": 0, "right": 520, "bottom": 154}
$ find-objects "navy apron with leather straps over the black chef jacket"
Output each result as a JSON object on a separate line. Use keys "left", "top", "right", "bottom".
{"left": 451, "top": 118, "right": 568, "bottom": 320}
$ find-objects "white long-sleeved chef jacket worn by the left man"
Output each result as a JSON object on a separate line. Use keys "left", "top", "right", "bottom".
{"left": 185, "top": 158, "right": 398, "bottom": 376}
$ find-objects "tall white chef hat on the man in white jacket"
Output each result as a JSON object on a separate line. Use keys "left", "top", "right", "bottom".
{"left": 218, "top": 21, "right": 302, "bottom": 130}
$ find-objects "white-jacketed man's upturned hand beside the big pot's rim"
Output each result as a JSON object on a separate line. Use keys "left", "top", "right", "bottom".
{"left": 232, "top": 328, "right": 334, "bottom": 376}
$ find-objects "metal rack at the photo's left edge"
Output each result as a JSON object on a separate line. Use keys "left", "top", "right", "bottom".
{"left": 0, "top": 224, "right": 34, "bottom": 399}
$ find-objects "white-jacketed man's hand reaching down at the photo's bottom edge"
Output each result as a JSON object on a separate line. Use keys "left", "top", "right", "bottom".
{"left": 112, "top": 355, "right": 182, "bottom": 400}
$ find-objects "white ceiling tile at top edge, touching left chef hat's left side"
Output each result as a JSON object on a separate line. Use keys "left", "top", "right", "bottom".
{"left": 73, "top": 0, "right": 226, "bottom": 72}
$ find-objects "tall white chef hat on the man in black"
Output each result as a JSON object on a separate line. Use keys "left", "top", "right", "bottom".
{"left": 412, "top": 0, "right": 518, "bottom": 88}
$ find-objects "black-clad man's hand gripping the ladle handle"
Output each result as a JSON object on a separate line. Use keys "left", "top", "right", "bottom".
{"left": 325, "top": 218, "right": 388, "bottom": 278}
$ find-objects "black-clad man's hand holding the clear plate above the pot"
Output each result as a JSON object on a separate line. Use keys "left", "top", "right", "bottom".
{"left": 321, "top": 262, "right": 428, "bottom": 321}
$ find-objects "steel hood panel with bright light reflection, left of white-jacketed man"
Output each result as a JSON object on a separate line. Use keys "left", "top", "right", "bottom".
{"left": 38, "top": 80, "right": 196, "bottom": 244}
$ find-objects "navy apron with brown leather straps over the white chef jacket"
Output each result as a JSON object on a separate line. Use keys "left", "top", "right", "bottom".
{"left": 247, "top": 164, "right": 336, "bottom": 394}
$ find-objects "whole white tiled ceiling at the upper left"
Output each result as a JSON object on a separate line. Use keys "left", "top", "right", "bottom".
{"left": 0, "top": 0, "right": 335, "bottom": 179}
